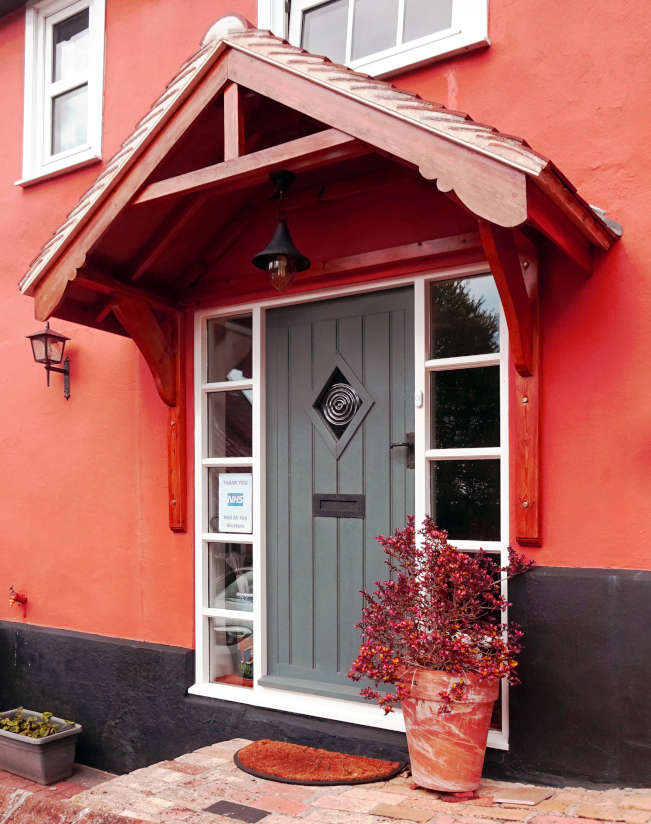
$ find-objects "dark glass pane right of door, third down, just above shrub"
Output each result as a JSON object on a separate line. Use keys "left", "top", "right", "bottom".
{"left": 430, "top": 459, "right": 500, "bottom": 542}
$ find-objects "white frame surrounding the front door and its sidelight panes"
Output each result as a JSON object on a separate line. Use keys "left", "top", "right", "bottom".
{"left": 188, "top": 261, "right": 516, "bottom": 750}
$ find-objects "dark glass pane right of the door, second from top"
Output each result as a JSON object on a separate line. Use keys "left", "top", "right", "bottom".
{"left": 430, "top": 366, "right": 500, "bottom": 449}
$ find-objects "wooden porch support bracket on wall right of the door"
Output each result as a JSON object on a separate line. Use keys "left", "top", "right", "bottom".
{"left": 479, "top": 219, "right": 541, "bottom": 546}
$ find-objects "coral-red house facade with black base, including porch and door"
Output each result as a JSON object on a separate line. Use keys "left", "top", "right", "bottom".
{"left": 0, "top": 0, "right": 651, "bottom": 786}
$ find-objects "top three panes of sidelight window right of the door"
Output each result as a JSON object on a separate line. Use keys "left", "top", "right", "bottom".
{"left": 425, "top": 275, "right": 504, "bottom": 545}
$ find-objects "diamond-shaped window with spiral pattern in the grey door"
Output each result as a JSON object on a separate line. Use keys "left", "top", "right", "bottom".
{"left": 305, "top": 353, "right": 374, "bottom": 458}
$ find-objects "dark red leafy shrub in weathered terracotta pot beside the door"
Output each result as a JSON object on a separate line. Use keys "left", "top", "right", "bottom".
{"left": 349, "top": 517, "right": 534, "bottom": 792}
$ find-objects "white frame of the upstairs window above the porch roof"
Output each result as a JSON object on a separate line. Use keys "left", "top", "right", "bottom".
{"left": 258, "top": 0, "right": 490, "bottom": 77}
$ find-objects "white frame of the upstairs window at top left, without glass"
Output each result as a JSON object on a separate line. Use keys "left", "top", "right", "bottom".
{"left": 16, "top": 0, "right": 106, "bottom": 186}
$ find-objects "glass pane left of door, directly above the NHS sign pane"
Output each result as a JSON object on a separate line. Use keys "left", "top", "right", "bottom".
{"left": 208, "top": 389, "right": 253, "bottom": 458}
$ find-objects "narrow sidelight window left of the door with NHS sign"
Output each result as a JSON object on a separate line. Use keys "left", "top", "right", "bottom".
{"left": 199, "top": 315, "right": 257, "bottom": 689}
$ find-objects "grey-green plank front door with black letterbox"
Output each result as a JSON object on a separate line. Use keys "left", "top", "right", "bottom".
{"left": 262, "top": 287, "right": 414, "bottom": 698}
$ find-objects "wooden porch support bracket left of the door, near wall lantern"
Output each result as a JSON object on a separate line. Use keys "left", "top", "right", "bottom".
{"left": 111, "top": 294, "right": 187, "bottom": 532}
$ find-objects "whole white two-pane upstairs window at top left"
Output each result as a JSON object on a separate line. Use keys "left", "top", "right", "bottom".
{"left": 19, "top": 0, "right": 105, "bottom": 184}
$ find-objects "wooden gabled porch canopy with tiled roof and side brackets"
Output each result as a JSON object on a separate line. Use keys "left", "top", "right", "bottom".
{"left": 20, "top": 15, "right": 620, "bottom": 544}
